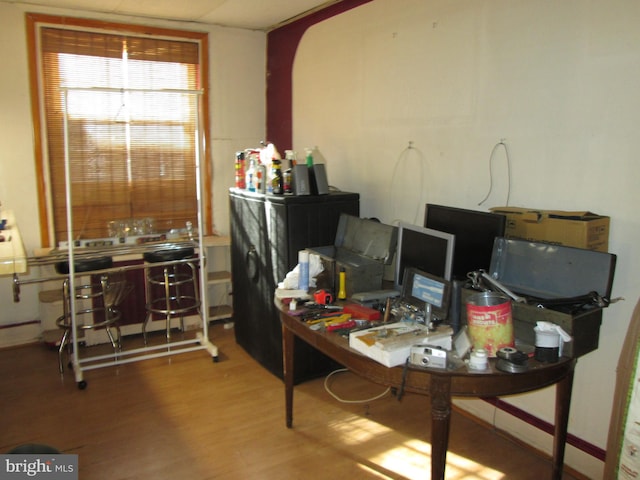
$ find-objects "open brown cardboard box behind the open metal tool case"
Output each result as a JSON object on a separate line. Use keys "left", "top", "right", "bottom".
{"left": 491, "top": 207, "right": 610, "bottom": 252}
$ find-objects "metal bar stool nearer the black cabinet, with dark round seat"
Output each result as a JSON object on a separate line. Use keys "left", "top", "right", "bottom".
{"left": 142, "top": 247, "right": 200, "bottom": 345}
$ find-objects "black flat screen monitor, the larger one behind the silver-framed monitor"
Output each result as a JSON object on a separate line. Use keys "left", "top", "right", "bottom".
{"left": 424, "top": 203, "right": 507, "bottom": 280}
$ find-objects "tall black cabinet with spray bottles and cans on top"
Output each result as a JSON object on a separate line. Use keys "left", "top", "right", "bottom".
{"left": 229, "top": 189, "right": 360, "bottom": 382}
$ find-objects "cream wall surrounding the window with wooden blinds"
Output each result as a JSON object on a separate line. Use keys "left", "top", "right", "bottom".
{"left": 0, "top": 3, "right": 266, "bottom": 347}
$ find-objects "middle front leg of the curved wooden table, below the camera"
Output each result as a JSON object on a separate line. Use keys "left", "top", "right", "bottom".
{"left": 431, "top": 375, "right": 451, "bottom": 480}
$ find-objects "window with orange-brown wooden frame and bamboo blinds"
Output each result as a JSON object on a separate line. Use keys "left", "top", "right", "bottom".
{"left": 27, "top": 14, "right": 211, "bottom": 245}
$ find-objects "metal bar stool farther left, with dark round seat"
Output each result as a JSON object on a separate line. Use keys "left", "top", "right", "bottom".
{"left": 55, "top": 257, "right": 130, "bottom": 373}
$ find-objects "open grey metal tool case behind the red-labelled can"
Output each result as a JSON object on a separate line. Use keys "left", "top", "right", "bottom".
{"left": 461, "top": 237, "right": 617, "bottom": 357}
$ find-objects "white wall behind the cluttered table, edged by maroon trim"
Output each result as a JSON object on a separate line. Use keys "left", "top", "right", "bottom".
{"left": 293, "top": 0, "right": 640, "bottom": 478}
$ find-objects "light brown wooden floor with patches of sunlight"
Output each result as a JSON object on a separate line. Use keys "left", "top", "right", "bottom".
{"left": 0, "top": 325, "right": 574, "bottom": 480}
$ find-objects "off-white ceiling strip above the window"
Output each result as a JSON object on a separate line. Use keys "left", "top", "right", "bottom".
{"left": 0, "top": 0, "right": 336, "bottom": 30}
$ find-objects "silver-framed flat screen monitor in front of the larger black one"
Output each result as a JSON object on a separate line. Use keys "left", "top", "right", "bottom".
{"left": 395, "top": 222, "right": 455, "bottom": 291}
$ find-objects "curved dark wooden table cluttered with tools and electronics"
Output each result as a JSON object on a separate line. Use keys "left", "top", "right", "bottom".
{"left": 278, "top": 304, "right": 576, "bottom": 479}
